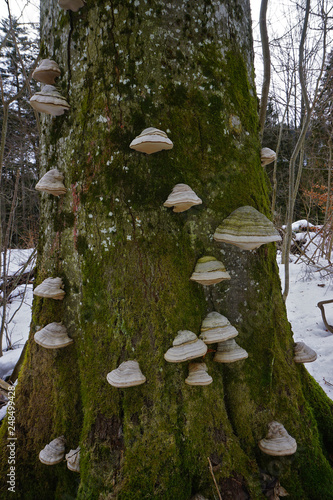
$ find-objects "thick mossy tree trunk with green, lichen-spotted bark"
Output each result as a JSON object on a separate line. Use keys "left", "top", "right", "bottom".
{"left": 1, "top": 0, "right": 333, "bottom": 500}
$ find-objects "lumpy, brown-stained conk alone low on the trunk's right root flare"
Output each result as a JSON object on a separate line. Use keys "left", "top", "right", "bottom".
{"left": 258, "top": 422, "right": 297, "bottom": 457}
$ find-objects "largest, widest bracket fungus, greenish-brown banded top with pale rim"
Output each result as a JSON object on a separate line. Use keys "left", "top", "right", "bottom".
{"left": 214, "top": 206, "right": 281, "bottom": 250}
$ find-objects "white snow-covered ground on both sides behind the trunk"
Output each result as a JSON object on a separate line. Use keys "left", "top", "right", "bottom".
{"left": 0, "top": 231, "right": 333, "bottom": 420}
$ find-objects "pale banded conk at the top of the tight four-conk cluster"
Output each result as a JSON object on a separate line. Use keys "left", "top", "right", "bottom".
{"left": 199, "top": 311, "right": 238, "bottom": 344}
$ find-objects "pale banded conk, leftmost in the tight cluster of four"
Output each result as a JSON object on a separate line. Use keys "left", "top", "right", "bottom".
{"left": 164, "top": 330, "right": 207, "bottom": 363}
